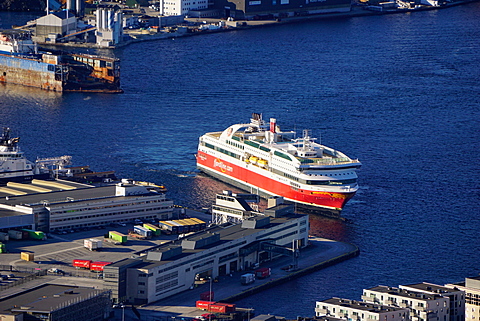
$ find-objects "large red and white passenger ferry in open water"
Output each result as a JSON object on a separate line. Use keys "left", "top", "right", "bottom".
{"left": 196, "top": 113, "right": 361, "bottom": 214}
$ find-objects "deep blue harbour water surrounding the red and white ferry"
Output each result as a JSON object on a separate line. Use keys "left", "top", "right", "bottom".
{"left": 0, "top": 2, "right": 480, "bottom": 317}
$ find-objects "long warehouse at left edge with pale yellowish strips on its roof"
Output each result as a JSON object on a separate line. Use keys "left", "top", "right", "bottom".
{"left": 0, "top": 180, "right": 173, "bottom": 232}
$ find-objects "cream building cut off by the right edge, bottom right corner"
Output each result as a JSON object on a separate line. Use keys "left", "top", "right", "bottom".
{"left": 445, "top": 276, "right": 480, "bottom": 321}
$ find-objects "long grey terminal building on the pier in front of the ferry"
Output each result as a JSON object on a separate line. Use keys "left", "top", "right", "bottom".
{"left": 104, "top": 200, "right": 309, "bottom": 304}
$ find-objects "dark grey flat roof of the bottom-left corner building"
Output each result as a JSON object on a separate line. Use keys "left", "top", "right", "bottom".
{"left": 0, "top": 284, "right": 105, "bottom": 314}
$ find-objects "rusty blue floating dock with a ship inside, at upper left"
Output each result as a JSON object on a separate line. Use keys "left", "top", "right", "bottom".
{"left": 0, "top": 30, "right": 123, "bottom": 93}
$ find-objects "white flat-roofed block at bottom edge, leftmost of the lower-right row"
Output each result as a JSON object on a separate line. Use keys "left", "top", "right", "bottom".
{"left": 315, "top": 298, "right": 410, "bottom": 321}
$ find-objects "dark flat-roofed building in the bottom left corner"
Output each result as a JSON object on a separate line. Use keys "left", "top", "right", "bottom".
{"left": 0, "top": 284, "right": 112, "bottom": 321}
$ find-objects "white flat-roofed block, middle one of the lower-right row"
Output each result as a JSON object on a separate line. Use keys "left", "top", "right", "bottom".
{"left": 362, "top": 285, "right": 450, "bottom": 321}
